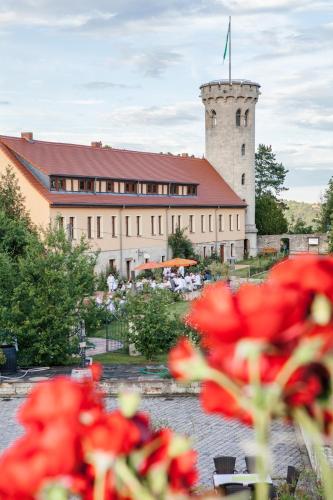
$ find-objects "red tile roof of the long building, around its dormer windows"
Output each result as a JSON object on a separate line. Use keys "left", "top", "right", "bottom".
{"left": 0, "top": 136, "right": 246, "bottom": 207}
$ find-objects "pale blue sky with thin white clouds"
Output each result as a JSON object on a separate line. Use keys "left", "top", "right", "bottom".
{"left": 0, "top": 0, "right": 333, "bottom": 202}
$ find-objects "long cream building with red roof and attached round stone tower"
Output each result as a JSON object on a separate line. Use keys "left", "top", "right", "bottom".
{"left": 0, "top": 81, "right": 259, "bottom": 277}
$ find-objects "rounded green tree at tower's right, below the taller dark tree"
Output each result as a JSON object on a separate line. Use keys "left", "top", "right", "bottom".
{"left": 256, "top": 194, "right": 288, "bottom": 234}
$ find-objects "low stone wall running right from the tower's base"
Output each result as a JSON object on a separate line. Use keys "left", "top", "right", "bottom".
{"left": 258, "top": 233, "right": 328, "bottom": 255}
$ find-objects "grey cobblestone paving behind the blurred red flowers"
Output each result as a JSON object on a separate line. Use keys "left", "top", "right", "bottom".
{"left": 0, "top": 397, "right": 303, "bottom": 487}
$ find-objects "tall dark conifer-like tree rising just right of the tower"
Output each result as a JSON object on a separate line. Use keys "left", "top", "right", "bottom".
{"left": 255, "top": 144, "right": 288, "bottom": 198}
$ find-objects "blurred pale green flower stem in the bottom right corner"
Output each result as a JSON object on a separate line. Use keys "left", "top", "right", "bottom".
{"left": 294, "top": 409, "right": 333, "bottom": 500}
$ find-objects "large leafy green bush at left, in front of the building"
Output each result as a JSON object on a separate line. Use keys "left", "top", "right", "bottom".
{"left": 6, "top": 228, "right": 95, "bottom": 365}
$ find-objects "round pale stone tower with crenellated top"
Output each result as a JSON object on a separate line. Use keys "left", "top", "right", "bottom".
{"left": 200, "top": 80, "right": 260, "bottom": 256}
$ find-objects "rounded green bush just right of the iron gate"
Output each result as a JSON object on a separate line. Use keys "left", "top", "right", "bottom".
{"left": 126, "top": 290, "right": 181, "bottom": 360}
